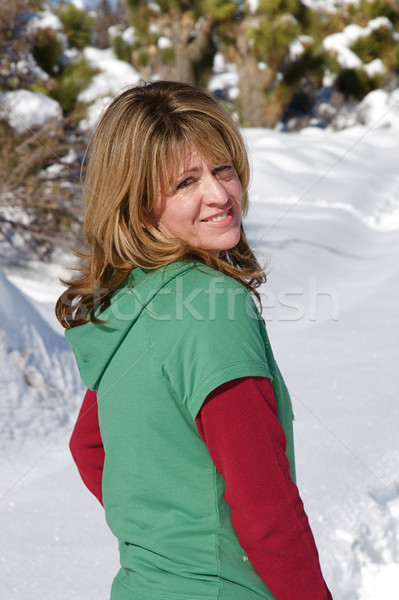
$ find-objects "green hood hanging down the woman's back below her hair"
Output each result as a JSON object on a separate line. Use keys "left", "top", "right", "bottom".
{"left": 65, "top": 261, "right": 194, "bottom": 390}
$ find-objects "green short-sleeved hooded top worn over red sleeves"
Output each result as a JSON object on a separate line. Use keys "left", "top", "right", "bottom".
{"left": 66, "top": 261, "right": 295, "bottom": 600}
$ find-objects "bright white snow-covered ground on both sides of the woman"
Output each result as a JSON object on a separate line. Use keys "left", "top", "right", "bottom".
{"left": 0, "top": 112, "right": 399, "bottom": 600}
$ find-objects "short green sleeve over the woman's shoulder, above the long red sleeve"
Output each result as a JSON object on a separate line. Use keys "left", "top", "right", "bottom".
{"left": 147, "top": 266, "right": 272, "bottom": 418}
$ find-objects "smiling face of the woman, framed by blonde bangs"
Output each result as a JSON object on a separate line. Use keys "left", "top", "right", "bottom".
{"left": 153, "top": 150, "right": 242, "bottom": 255}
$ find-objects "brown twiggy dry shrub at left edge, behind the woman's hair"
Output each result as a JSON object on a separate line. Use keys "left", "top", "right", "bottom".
{"left": 0, "top": 116, "right": 85, "bottom": 259}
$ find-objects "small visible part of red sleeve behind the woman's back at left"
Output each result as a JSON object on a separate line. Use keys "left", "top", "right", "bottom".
{"left": 69, "top": 390, "right": 105, "bottom": 504}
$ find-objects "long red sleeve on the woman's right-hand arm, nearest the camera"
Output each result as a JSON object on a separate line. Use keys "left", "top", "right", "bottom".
{"left": 196, "top": 377, "right": 332, "bottom": 600}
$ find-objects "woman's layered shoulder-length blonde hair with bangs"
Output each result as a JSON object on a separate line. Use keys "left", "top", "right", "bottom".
{"left": 56, "top": 81, "right": 266, "bottom": 328}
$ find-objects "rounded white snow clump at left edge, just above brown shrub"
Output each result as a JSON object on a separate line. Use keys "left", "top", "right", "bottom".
{"left": 0, "top": 90, "right": 62, "bottom": 133}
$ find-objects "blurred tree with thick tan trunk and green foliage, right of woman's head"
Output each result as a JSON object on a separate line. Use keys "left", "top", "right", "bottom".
{"left": 220, "top": 0, "right": 325, "bottom": 127}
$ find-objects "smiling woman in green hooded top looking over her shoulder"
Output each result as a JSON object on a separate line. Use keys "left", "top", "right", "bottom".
{"left": 57, "top": 82, "right": 331, "bottom": 600}
